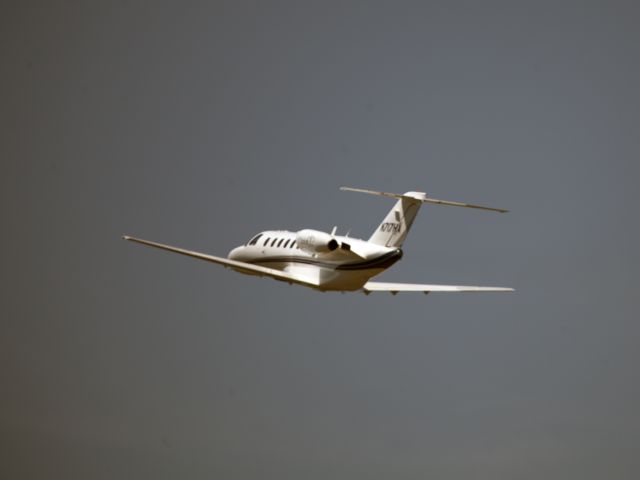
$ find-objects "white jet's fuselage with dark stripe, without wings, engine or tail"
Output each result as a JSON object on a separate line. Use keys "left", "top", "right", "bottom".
{"left": 228, "top": 230, "right": 402, "bottom": 290}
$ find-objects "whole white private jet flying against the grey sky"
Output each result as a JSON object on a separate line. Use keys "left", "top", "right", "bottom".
{"left": 122, "top": 187, "right": 513, "bottom": 295}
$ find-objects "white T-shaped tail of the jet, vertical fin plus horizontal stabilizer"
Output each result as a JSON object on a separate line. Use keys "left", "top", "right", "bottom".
{"left": 340, "top": 187, "right": 508, "bottom": 247}
